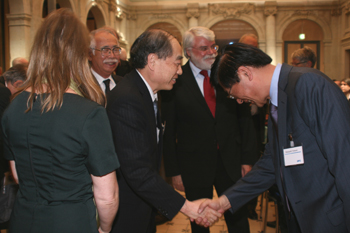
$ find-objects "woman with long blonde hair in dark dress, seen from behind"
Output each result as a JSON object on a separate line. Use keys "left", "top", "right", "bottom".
{"left": 1, "top": 9, "right": 119, "bottom": 233}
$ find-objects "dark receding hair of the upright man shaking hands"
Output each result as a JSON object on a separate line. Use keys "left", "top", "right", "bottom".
{"left": 129, "top": 29, "right": 175, "bottom": 69}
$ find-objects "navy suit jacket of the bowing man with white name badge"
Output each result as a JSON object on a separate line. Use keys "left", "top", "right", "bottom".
{"left": 225, "top": 64, "right": 350, "bottom": 233}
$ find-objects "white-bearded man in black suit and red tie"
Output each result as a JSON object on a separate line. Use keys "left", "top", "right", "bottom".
{"left": 161, "top": 27, "right": 257, "bottom": 233}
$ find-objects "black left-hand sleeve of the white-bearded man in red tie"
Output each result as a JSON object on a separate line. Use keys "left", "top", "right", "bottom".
{"left": 161, "top": 87, "right": 181, "bottom": 177}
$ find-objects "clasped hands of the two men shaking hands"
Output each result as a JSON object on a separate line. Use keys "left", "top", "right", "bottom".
{"left": 180, "top": 195, "right": 231, "bottom": 227}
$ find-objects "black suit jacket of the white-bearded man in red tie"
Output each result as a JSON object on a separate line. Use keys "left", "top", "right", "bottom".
{"left": 162, "top": 62, "right": 257, "bottom": 188}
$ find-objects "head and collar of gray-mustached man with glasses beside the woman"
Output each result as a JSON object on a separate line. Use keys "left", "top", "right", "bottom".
{"left": 89, "top": 28, "right": 122, "bottom": 95}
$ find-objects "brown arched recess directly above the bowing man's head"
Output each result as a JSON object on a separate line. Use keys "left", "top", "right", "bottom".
{"left": 210, "top": 19, "right": 258, "bottom": 53}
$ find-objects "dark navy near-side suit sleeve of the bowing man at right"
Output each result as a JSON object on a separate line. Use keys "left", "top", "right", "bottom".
{"left": 295, "top": 73, "right": 350, "bottom": 229}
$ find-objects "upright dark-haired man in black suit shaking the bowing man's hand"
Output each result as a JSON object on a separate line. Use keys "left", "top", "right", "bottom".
{"left": 107, "top": 30, "right": 220, "bottom": 233}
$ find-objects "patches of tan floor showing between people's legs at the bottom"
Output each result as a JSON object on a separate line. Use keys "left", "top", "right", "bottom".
{"left": 157, "top": 192, "right": 276, "bottom": 233}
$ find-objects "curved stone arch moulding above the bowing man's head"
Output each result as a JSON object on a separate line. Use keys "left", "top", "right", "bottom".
{"left": 202, "top": 15, "right": 265, "bottom": 45}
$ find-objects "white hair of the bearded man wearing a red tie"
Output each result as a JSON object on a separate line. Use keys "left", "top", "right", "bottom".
{"left": 183, "top": 27, "right": 215, "bottom": 58}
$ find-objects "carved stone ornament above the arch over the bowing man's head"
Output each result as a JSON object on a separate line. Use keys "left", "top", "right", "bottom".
{"left": 209, "top": 3, "right": 255, "bottom": 18}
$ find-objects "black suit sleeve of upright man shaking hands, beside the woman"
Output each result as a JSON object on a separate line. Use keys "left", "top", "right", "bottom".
{"left": 107, "top": 93, "right": 185, "bottom": 219}
